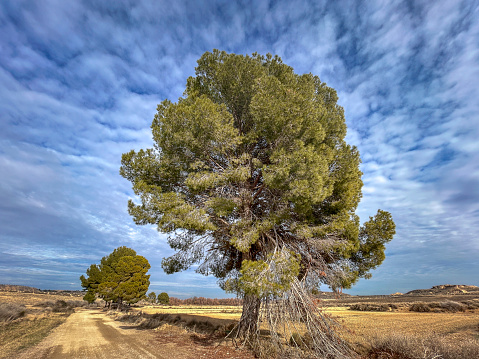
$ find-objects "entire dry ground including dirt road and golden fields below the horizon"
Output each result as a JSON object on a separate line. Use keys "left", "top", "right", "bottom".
{"left": 0, "top": 285, "right": 479, "bottom": 359}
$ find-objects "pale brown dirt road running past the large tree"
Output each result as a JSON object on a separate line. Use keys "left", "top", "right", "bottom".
{"left": 19, "top": 310, "right": 250, "bottom": 359}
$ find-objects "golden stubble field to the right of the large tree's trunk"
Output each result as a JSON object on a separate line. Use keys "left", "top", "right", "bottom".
{"left": 328, "top": 307, "right": 479, "bottom": 359}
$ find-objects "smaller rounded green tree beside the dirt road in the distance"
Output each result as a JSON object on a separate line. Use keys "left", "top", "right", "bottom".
{"left": 80, "top": 247, "right": 150, "bottom": 305}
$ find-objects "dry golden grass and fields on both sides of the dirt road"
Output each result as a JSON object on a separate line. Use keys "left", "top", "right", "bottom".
{"left": 0, "top": 292, "right": 479, "bottom": 359}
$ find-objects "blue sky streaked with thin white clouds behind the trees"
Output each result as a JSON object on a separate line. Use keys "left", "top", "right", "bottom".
{"left": 0, "top": 0, "right": 479, "bottom": 298}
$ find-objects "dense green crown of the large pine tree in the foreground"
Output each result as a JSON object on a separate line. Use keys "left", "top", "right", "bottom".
{"left": 120, "top": 50, "right": 395, "bottom": 296}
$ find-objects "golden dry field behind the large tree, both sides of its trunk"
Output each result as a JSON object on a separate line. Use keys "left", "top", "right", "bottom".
{"left": 136, "top": 296, "right": 479, "bottom": 359}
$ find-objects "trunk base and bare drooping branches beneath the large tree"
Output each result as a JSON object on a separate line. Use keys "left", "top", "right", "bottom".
{"left": 230, "top": 280, "right": 352, "bottom": 359}
